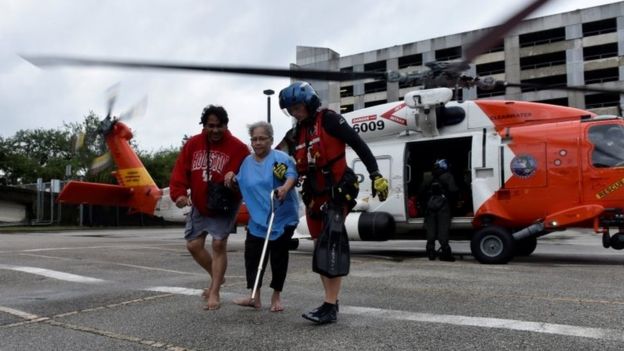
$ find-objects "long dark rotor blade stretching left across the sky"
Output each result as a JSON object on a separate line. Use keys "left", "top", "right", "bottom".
{"left": 21, "top": 55, "right": 387, "bottom": 82}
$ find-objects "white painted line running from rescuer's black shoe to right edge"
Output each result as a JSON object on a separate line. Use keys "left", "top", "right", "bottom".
{"left": 340, "top": 306, "right": 624, "bottom": 341}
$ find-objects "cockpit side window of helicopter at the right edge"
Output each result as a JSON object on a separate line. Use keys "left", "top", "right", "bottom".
{"left": 589, "top": 124, "right": 624, "bottom": 168}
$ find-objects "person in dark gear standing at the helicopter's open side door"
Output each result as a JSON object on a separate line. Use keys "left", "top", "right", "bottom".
{"left": 419, "top": 159, "right": 459, "bottom": 262}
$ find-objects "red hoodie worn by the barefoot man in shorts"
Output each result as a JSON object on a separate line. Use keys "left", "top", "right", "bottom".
{"left": 169, "top": 130, "right": 249, "bottom": 216}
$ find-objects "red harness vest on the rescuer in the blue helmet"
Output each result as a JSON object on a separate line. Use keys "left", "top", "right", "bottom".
{"left": 294, "top": 109, "right": 347, "bottom": 192}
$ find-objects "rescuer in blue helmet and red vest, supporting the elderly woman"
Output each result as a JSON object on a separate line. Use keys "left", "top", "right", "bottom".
{"left": 279, "top": 82, "right": 388, "bottom": 324}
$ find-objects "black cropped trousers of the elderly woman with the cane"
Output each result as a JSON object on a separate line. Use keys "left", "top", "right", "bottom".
{"left": 245, "top": 227, "right": 295, "bottom": 291}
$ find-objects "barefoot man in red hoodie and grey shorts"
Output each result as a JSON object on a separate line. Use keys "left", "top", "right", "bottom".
{"left": 169, "top": 105, "right": 249, "bottom": 310}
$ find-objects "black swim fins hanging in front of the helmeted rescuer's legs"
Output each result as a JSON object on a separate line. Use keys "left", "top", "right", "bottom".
{"left": 312, "top": 203, "right": 351, "bottom": 278}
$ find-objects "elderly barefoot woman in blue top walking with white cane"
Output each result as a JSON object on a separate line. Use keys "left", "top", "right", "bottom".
{"left": 234, "top": 122, "right": 299, "bottom": 312}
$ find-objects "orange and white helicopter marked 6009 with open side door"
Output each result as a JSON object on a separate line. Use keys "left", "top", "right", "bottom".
{"left": 25, "top": 0, "right": 624, "bottom": 263}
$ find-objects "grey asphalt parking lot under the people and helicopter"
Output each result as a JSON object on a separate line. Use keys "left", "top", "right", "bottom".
{"left": 0, "top": 228, "right": 624, "bottom": 351}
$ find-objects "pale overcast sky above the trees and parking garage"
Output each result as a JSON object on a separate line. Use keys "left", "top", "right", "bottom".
{"left": 0, "top": 0, "right": 616, "bottom": 151}
